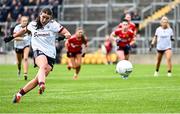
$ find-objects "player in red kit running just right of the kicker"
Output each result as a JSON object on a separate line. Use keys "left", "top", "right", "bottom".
{"left": 65, "top": 28, "right": 87, "bottom": 80}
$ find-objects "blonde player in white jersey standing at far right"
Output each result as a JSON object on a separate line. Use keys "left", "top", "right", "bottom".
{"left": 151, "top": 16, "right": 174, "bottom": 77}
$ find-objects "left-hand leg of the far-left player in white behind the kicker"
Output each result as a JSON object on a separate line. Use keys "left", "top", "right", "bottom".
{"left": 16, "top": 49, "right": 22, "bottom": 76}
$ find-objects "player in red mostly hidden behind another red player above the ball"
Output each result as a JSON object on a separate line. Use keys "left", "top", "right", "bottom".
{"left": 118, "top": 13, "right": 137, "bottom": 35}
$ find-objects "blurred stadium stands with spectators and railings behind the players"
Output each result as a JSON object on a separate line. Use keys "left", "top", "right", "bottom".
{"left": 0, "top": 0, "right": 180, "bottom": 64}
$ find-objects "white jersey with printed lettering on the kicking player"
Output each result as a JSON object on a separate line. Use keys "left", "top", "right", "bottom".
{"left": 27, "top": 20, "right": 63, "bottom": 58}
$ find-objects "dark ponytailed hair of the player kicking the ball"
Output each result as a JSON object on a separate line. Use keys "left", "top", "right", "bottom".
{"left": 36, "top": 8, "right": 53, "bottom": 29}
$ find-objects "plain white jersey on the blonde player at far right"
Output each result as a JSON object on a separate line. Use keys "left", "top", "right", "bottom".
{"left": 155, "top": 27, "right": 173, "bottom": 50}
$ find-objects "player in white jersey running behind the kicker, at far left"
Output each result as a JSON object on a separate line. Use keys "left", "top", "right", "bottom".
{"left": 13, "top": 16, "right": 30, "bottom": 80}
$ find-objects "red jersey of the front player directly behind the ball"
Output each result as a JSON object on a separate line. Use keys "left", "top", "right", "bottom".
{"left": 114, "top": 28, "right": 134, "bottom": 47}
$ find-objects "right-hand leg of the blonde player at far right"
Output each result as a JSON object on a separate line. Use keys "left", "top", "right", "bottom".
{"left": 165, "top": 49, "right": 172, "bottom": 77}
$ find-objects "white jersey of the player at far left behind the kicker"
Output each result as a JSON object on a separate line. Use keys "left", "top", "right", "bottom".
{"left": 13, "top": 24, "right": 31, "bottom": 49}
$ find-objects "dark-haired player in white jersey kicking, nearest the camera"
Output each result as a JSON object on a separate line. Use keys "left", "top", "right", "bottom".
{"left": 4, "top": 8, "right": 71, "bottom": 103}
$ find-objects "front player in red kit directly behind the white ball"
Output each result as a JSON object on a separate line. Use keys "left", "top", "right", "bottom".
{"left": 111, "top": 19, "right": 135, "bottom": 60}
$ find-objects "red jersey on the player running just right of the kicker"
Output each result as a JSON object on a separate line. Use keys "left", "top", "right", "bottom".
{"left": 67, "top": 35, "right": 87, "bottom": 52}
